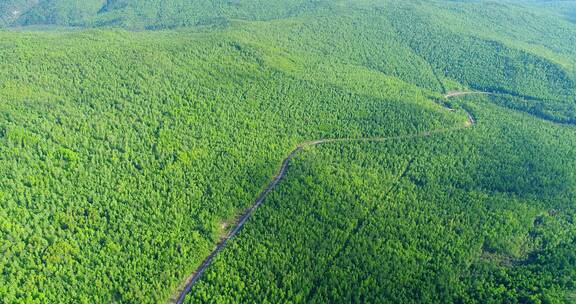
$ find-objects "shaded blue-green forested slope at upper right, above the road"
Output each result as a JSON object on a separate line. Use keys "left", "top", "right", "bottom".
{"left": 390, "top": 1, "right": 576, "bottom": 102}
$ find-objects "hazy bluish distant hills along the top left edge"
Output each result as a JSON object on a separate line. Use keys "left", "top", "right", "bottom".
{"left": 0, "top": 0, "right": 330, "bottom": 29}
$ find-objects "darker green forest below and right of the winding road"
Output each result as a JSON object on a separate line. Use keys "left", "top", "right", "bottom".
{"left": 190, "top": 98, "right": 576, "bottom": 303}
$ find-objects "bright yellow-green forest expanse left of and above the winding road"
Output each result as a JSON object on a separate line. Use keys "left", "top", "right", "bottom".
{"left": 0, "top": 27, "right": 464, "bottom": 302}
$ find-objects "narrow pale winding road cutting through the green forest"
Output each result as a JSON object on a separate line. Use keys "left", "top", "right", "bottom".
{"left": 168, "top": 91, "right": 482, "bottom": 304}
